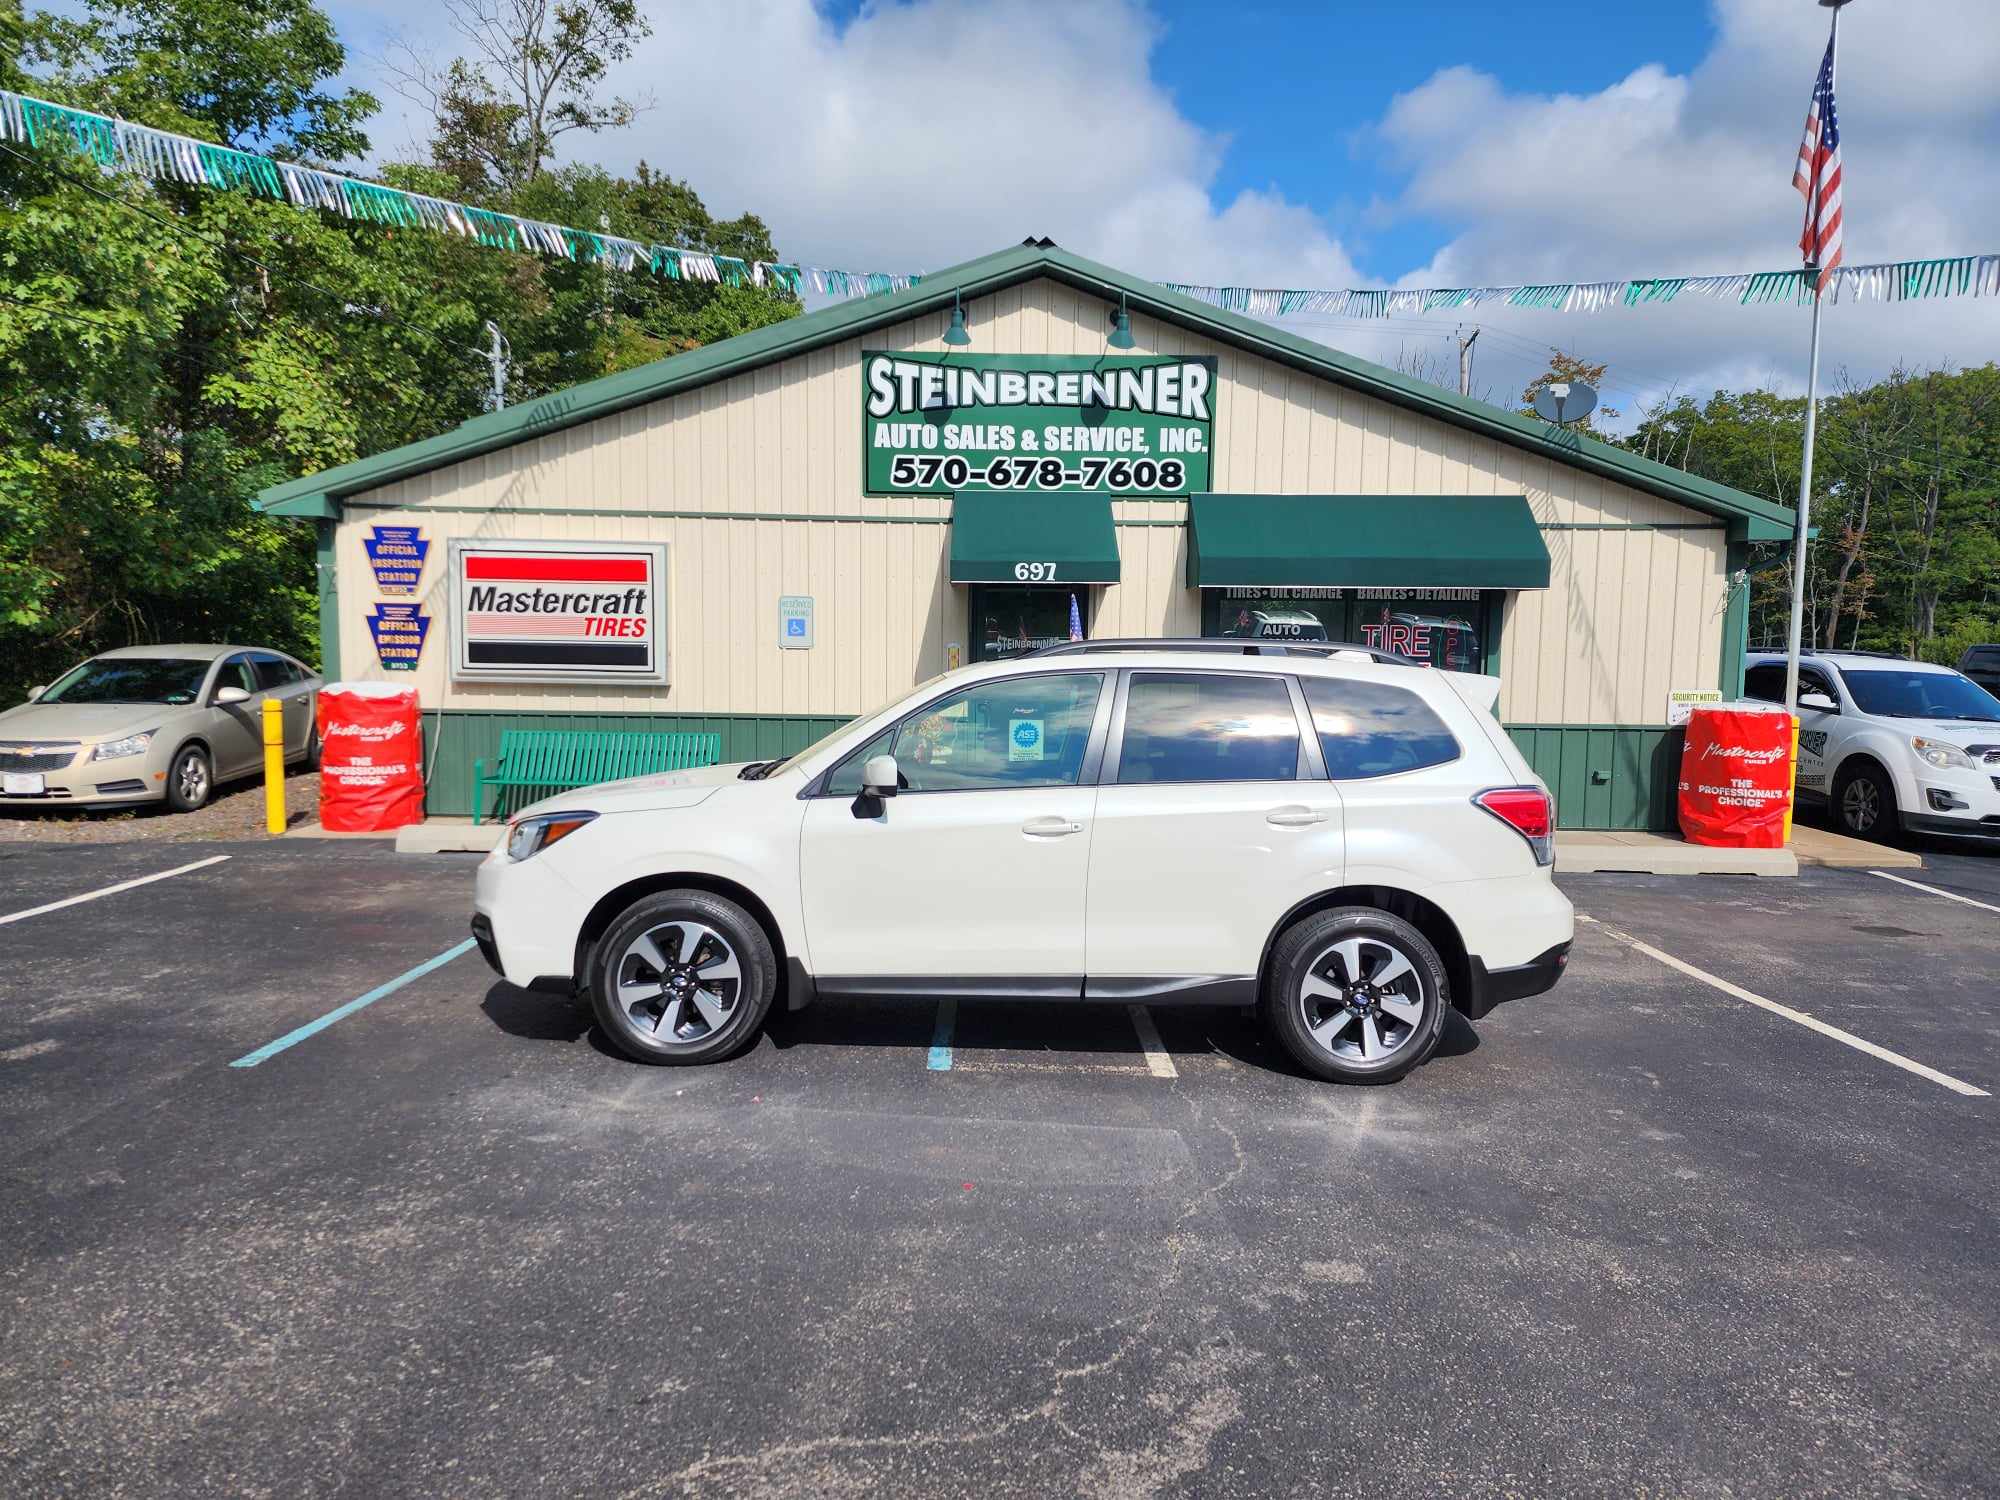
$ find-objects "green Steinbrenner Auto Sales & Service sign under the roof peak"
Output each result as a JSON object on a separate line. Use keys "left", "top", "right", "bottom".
{"left": 862, "top": 350, "right": 1216, "bottom": 496}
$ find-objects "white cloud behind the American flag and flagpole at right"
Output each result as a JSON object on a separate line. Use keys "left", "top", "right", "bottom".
{"left": 1378, "top": 0, "right": 2000, "bottom": 414}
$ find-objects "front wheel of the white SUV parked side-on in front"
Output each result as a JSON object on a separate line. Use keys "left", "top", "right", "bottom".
{"left": 588, "top": 890, "right": 778, "bottom": 1066}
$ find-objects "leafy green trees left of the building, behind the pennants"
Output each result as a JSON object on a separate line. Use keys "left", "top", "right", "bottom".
{"left": 0, "top": 0, "right": 798, "bottom": 702}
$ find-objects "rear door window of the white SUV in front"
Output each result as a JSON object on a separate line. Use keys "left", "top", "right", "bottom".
{"left": 1118, "top": 672, "right": 1298, "bottom": 782}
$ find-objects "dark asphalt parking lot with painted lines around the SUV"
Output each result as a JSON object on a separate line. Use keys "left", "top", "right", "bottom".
{"left": 0, "top": 840, "right": 2000, "bottom": 1496}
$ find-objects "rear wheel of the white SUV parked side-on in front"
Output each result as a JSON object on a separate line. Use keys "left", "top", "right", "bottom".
{"left": 1258, "top": 906, "right": 1452, "bottom": 1082}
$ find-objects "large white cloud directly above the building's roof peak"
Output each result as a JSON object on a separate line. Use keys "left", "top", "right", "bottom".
{"left": 346, "top": 0, "right": 1356, "bottom": 284}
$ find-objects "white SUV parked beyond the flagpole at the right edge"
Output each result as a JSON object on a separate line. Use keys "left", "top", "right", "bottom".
{"left": 1744, "top": 652, "right": 2000, "bottom": 838}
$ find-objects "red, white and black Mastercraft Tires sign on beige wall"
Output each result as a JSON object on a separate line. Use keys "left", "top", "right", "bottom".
{"left": 450, "top": 540, "right": 666, "bottom": 682}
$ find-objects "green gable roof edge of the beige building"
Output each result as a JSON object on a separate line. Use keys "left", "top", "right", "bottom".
{"left": 256, "top": 244, "right": 1792, "bottom": 542}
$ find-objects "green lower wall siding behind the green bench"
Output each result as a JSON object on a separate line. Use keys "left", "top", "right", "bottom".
{"left": 424, "top": 708, "right": 854, "bottom": 818}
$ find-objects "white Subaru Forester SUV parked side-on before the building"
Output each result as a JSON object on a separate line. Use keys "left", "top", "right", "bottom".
{"left": 472, "top": 640, "right": 1574, "bottom": 1080}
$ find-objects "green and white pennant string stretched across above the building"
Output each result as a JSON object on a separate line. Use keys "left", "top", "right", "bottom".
{"left": 0, "top": 88, "right": 2000, "bottom": 318}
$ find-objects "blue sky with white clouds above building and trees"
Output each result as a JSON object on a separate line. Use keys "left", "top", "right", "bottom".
{"left": 320, "top": 0, "right": 2000, "bottom": 424}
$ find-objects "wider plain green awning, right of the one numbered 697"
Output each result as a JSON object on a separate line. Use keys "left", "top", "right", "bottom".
{"left": 1188, "top": 494, "right": 1548, "bottom": 588}
